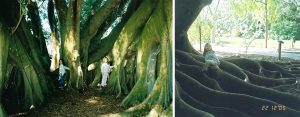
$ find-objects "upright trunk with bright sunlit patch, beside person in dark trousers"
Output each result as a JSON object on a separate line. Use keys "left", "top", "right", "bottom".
{"left": 61, "top": 0, "right": 83, "bottom": 89}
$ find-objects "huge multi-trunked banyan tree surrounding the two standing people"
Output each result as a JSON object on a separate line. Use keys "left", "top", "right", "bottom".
{"left": 0, "top": 0, "right": 172, "bottom": 117}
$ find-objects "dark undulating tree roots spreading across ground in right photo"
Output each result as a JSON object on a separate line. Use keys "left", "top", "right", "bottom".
{"left": 175, "top": 50, "right": 300, "bottom": 117}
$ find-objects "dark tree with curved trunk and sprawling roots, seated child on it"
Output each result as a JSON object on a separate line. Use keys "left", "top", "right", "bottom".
{"left": 175, "top": 0, "right": 300, "bottom": 117}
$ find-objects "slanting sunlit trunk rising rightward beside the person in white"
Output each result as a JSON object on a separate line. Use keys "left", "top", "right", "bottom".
{"left": 108, "top": 0, "right": 156, "bottom": 96}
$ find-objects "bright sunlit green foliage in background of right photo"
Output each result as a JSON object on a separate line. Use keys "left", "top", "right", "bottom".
{"left": 188, "top": 0, "right": 300, "bottom": 43}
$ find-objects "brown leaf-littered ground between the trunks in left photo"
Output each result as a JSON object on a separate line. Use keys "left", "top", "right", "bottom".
{"left": 25, "top": 87, "right": 125, "bottom": 117}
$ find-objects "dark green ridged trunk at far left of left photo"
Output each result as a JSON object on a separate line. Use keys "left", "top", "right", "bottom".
{"left": 0, "top": 1, "right": 52, "bottom": 116}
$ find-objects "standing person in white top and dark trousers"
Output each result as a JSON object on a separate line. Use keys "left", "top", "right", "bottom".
{"left": 58, "top": 60, "right": 70, "bottom": 89}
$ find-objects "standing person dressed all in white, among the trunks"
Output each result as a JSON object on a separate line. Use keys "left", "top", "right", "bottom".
{"left": 100, "top": 58, "right": 113, "bottom": 87}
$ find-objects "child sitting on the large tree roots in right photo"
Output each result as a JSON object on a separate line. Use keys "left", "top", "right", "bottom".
{"left": 203, "top": 43, "right": 220, "bottom": 71}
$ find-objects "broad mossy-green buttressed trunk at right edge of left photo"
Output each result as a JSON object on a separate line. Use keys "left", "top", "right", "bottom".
{"left": 122, "top": 0, "right": 172, "bottom": 116}
